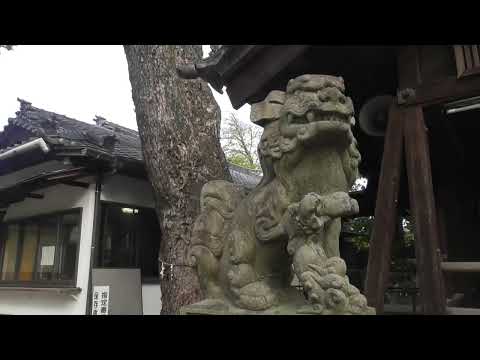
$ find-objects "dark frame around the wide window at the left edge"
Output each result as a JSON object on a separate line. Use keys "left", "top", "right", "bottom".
{"left": 0, "top": 207, "right": 83, "bottom": 288}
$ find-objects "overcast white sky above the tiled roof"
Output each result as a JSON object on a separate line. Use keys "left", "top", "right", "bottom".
{"left": 0, "top": 45, "right": 250, "bottom": 131}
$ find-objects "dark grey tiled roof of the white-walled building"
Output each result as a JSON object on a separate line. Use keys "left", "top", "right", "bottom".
{"left": 0, "top": 99, "right": 261, "bottom": 188}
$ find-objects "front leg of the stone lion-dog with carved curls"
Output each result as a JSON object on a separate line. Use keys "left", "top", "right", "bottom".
{"left": 286, "top": 192, "right": 374, "bottom": 315}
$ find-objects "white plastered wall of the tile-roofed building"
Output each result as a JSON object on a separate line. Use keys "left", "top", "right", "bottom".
{"left": 0, "top": 175, "right": 161, "bottom": 315}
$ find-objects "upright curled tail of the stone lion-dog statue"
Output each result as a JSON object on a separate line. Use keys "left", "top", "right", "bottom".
{"left": 188, "top": 180, "right": 246, "bottom": 298}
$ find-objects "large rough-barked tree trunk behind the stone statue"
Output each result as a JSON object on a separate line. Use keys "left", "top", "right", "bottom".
{"left": 124, "top": 45, "right": 230, "bottom": 314}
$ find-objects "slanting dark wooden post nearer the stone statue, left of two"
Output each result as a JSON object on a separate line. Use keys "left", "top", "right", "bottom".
{"left": 365, "top": 103, "right": 404, "bottom": 314}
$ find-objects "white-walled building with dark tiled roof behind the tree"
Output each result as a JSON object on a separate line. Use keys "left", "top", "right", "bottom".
{"left": 0, "top": 100, "right": 261, "bottom": 314}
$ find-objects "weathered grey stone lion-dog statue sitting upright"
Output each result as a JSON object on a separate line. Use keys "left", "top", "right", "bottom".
{"left": 189, "top": 75, "right": 374, "bottom": 314}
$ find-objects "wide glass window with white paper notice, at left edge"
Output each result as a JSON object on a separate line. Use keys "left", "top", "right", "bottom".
{"left": 0, "top": 211, "right": 81, "bottom": 284}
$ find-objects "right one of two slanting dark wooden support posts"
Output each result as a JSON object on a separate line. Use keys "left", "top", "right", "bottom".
{"left": 403, "top": 106, "right": 446, "bottom": 314}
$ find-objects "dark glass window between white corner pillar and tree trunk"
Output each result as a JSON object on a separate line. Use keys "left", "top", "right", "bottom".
{"left": 99, "top": 204, "right": 160, "bottom": 281}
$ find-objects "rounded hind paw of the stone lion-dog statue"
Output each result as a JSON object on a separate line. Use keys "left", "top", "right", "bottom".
{"left": 236, "top": 281, "right": 278, "bottom": 311}
